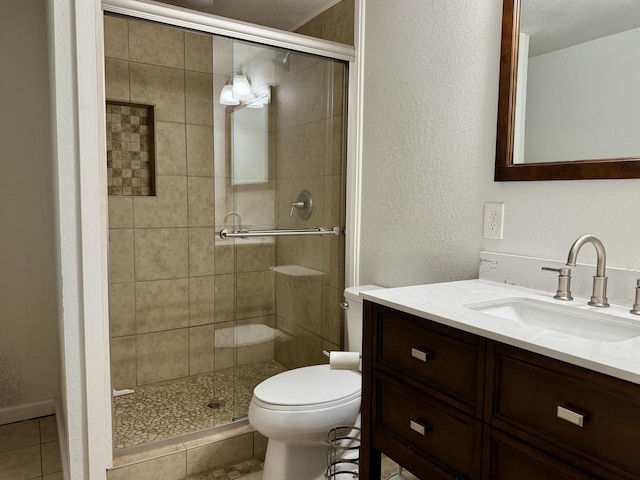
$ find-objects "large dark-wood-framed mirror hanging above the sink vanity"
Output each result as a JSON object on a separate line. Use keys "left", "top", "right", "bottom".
{"left": 495, "top": 0, "right": 640, "bottom": 181}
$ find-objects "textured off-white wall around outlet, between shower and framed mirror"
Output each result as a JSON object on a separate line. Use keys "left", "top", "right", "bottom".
{"left": 360, "top": 0, "right": 640, "bottom": 288}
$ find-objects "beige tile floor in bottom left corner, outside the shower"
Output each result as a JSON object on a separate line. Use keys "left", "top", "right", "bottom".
{"left": 0, "top": 415, "right": 62, "bottom": 480}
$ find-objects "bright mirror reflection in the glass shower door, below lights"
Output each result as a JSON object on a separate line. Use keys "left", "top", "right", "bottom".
{"left": 231, "top": 97, "right": 269, "bottom": 185}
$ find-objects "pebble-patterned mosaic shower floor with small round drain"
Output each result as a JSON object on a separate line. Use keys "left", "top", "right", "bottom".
{"left": 114, "top": 362, "right": 286, "bottom": 449}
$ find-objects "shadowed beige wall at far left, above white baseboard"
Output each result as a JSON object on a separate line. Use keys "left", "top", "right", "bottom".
{"left": 0, "top": 0, "right": 59, "bottom": 409}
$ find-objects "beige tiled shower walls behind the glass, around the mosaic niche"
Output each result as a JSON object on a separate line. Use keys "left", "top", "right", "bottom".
{"left": 105, "top": 12, "right": 345, "bottom": 389}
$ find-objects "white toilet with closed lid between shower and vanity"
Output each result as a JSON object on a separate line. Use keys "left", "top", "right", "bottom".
{"left": 249, "top": 285, "right": 381, "bottom": 480}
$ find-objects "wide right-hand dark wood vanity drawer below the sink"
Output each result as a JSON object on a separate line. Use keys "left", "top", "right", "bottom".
{"left": 488, "top": 344, "right": 640, "bottom": 478}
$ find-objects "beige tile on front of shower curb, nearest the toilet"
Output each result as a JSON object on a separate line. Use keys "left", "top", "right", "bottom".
{"left": 187, "top": 433, "right": 253, "bottom": 475}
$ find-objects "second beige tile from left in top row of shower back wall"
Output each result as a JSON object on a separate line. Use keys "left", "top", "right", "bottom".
{"left": 129, "top": 21, "right": 184, "bottom": 68}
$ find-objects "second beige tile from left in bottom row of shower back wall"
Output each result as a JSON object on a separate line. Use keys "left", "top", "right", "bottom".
{"left": 136, "top": 328, "right": 189, "bottom": 385}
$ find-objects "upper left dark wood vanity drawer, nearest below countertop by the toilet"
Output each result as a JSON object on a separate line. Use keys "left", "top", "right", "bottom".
{"left": 373, "top": 305, "right": 485, "bottom": 415}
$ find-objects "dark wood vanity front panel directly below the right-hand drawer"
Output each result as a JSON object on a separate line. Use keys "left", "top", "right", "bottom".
{"left": 484, "top": 429, "right": 599, "bottom": 480}
